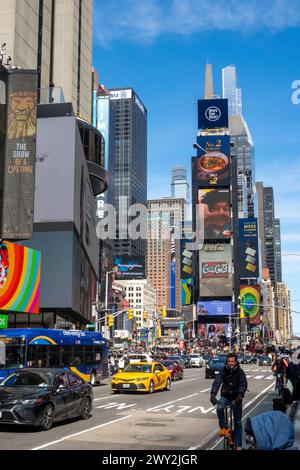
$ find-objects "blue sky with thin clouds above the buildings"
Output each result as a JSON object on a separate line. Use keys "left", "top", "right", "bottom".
{"left": 94, "top": 0, "right": 300, "bottom": 336}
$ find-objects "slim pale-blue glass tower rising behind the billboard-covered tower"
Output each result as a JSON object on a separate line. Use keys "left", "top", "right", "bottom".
{"left": 222, "top": 65, "right": 243, "bottom": 116}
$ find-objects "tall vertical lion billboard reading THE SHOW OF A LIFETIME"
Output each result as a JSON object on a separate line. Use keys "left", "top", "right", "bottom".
{"left": 0, "top": 70, "right": 37, "bottom": 240}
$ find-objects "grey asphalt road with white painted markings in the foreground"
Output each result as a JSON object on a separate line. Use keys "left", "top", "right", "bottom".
{"left": 0, "top": 365, "right": 274, "bottom": 451}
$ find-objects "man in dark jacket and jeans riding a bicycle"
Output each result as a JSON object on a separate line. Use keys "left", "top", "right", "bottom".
{"left": 210, "top": 353, "right": 248, "bottom": 450}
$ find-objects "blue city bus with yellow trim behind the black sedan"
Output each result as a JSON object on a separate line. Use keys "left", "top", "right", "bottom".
{"left": 0, "top": 328, "right": 109, "bottom": 385}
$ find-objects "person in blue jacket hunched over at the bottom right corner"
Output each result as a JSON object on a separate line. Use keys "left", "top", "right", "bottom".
{"left": 245, "top": 411, "right": 299, "bottom": 450}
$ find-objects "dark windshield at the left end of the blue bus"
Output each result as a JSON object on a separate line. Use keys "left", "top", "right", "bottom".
{"left": 0, "top": 338, "right": 25, "bottom": 369}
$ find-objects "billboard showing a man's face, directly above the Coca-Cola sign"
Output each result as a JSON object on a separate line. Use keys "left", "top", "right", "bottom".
{"left": 197, "top": 189, "right": 231, "bottom": 240}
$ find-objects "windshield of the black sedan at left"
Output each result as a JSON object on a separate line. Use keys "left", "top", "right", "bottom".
{"left": 0, "top": 371, "right": 54, "bottom": 388}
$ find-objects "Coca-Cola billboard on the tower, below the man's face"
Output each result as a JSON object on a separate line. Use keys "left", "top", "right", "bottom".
{"left": 199, "top": 243, "right": 232, "bottom": 297}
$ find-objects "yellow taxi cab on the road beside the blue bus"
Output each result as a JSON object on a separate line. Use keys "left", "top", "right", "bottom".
{"left": 111, "top": 362, "right": 171, "bottom": 393}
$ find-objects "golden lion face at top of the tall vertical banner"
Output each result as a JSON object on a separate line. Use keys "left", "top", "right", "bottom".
{"left": 8, "top": 91, "right": 37, "bottom": 139}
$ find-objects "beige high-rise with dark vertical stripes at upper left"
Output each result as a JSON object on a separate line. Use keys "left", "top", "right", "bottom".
{"left": 0, "top": 0, "right": 93, "bottom": 122}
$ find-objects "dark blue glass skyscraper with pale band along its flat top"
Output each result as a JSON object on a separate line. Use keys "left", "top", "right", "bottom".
{"left": 110, "top": 88, "right": 147, "bottom": 256}
